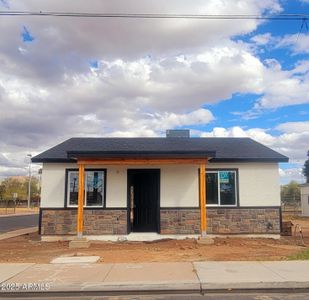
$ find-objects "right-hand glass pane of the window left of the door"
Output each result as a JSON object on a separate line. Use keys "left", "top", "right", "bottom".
{"left": 85, "top": 171, "right": 104, "bottom": 206}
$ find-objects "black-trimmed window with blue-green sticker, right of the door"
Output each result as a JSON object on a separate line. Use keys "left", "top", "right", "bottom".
{"left": 206, "top": 170, "right": 237, "bottom": 206}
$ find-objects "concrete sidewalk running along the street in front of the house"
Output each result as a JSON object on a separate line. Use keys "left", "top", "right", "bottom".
{"left": 0, "top": 261, "right": 309, "bottom": 297}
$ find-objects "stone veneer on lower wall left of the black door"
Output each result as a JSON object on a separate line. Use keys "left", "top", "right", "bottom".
{"left": 41, "top": 208, "right": 127, "bottom": 235}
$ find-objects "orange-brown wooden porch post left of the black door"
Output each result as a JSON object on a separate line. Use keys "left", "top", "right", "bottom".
{"left": 77, "top": 164, "right": 85, "bottom": 238}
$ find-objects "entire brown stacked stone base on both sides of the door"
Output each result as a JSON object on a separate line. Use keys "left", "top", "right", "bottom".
{"left": 40, "top": 207, "right": 280, "bottom": 235}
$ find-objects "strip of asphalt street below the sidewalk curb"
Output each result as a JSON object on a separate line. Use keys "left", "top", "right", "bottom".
{"left": 0, "top": 293, "right": 309, "bottom": 300}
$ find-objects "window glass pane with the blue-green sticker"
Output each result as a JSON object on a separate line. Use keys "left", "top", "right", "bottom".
{"left": 219, "top": 171, "right": 236, "bottom": 205}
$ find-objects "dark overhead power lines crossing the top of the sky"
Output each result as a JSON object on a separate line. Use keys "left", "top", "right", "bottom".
{"left": 0, "top": 11, "right": 309, "bottom": 21}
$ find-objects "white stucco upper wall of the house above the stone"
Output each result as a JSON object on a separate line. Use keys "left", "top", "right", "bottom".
{"left": 41, "top": 163, "right": 280, "bottom": 207}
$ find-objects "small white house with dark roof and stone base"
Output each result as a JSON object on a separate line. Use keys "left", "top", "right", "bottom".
{"left": 32, "top": 131, "right": 288, "bottom": 240}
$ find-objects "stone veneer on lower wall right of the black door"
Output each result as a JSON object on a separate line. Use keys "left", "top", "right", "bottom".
{"left": 161, "top": 207, "right": 280, "bottom": 234}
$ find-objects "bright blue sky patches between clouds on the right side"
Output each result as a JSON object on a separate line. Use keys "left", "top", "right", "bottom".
{"left": 205, "top": 1, "right": 309, "bottom": 127}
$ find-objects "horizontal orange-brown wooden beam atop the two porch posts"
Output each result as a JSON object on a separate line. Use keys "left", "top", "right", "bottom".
{"left": 78, "top": 158, "right": 205, "bottom": 165}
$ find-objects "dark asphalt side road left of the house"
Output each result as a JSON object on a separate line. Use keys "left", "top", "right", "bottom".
{"left": 0, "top": 214, "right": 39, "bottom": 234}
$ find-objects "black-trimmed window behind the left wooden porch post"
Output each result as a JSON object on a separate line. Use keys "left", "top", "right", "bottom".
{"left": 67, "top": 170, "right": 105, "bottom": 207}
